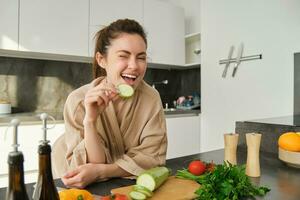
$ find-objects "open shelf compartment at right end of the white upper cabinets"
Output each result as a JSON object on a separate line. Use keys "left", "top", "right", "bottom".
{"left": 185, "top": 32, "right": 201, "bottom": 66}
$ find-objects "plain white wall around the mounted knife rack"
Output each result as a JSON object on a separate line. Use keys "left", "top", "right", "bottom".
{"left": 200, "top": 0, "right": 300, "bottom": 151}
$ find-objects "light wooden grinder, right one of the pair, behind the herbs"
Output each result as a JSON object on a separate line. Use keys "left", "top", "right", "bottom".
{"left": 246, "top": 133, "right": 261, "bottom": 177}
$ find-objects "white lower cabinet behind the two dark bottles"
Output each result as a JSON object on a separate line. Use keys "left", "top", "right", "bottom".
{"left": 0, "top": 123, "right": 65, "bottom": 187}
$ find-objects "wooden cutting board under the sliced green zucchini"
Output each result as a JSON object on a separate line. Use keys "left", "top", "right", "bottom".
{"left": 111, "top": 176, "right": 200, "bottom": 200}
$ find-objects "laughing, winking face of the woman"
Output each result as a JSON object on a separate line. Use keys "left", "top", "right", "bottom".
{"left": 99, "top": 33, "right": 147, "bottom": 88}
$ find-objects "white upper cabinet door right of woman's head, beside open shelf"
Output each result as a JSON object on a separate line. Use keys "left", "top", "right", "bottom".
{"left": 144, "top": 0, "right": 185, "bottom": 65}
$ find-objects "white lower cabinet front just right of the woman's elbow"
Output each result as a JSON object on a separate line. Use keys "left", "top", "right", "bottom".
{"left": 166, "top": 115, "right": 200, "bottom": 159}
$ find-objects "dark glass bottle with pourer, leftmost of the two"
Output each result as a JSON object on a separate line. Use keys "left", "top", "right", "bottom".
{"left": 6, "top": 119, "right": 29, "bottom": 200}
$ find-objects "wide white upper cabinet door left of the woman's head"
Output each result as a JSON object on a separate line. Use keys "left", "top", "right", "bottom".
{"left": 19, "top": 0, "right": 89, "bottom": 56}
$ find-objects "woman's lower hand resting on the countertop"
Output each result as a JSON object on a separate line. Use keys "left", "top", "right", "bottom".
{"left": 61, "top": 163, "right": 105, "bottom": 188}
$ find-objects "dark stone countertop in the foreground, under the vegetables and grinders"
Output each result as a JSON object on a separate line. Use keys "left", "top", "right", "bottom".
{"left": 0, "top": 149, "right": 300, "bottom": 200}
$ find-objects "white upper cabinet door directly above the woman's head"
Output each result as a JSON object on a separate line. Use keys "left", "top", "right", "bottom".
{"left": 90, "top": 0, "right": 143, "bottom": 26}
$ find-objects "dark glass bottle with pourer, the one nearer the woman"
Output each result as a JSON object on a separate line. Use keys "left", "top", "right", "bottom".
{"left": 33, "top": 113, "right": 59, "bottom": 200}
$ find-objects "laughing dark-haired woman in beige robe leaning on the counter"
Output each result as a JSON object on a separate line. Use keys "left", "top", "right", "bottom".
{"left": 52, "top": 19, "right": 167, "bottom": 188}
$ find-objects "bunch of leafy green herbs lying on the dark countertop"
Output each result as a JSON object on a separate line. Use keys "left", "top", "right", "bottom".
{"left": 176, "top": 162, "right": 270, "bottom": 200}
